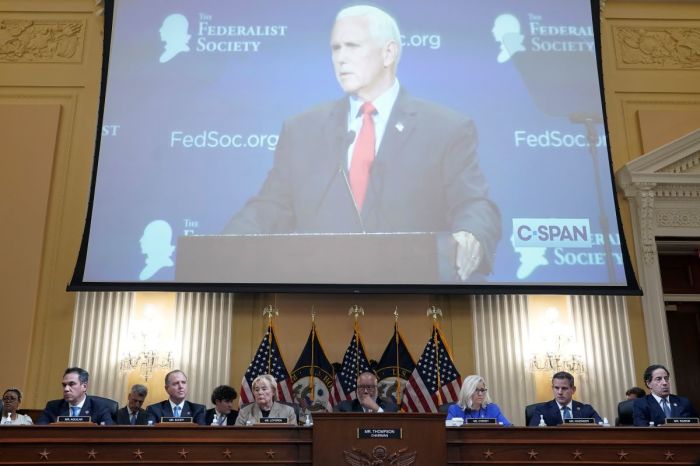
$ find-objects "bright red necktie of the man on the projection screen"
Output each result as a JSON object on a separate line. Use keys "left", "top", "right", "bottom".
{"left": 350, "top": 102, "right": 375, "bottom": 210}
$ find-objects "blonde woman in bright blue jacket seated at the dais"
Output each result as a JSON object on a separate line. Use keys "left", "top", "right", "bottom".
{"left": 447, "top": 375, "right": 513, "bottom": 426}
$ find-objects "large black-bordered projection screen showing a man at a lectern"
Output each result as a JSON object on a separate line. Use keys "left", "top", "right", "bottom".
{"left": 69, "top": 0, "right": 639, "bottom": 294}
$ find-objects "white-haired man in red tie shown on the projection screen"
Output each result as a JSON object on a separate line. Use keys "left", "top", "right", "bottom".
{"left": 224, "top": 5, "right": 501, "bottom": 281}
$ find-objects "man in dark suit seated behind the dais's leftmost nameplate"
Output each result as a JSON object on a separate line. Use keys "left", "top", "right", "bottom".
{"left": 36, "top": 367, "right": 114, "bottom": 425}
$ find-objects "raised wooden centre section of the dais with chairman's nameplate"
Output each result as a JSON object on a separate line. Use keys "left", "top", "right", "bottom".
{"left": 313, "top": 413, "right": 446, "bottom": 466}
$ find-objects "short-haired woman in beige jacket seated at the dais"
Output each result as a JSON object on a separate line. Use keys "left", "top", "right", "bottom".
{"left": 236, "top": 374, "right": 297, "bottom": 426}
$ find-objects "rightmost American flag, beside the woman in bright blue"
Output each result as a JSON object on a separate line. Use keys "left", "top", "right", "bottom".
{"left": 403, "top": 324, "right": 462, "bottom": 413}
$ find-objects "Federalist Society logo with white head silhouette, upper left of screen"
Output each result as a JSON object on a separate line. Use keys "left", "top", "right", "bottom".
{"left": 159, "top": 13, "right": 287, "bottom": 63}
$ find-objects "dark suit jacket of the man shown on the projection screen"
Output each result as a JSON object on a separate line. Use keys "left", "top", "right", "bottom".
{"left": 224, "top": 90, "right": 501, "bottom": 277}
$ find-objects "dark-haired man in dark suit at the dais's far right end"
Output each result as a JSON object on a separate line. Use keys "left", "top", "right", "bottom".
{"left": 632, "top": 364, "right": 698, "bottom": 426}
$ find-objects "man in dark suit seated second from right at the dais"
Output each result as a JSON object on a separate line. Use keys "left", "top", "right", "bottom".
{"left": 529, "top": 371, "right": 603, "bottom": 426}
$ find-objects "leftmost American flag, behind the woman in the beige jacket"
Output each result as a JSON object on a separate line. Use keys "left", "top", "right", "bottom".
{"left": 240, "top": 325, "right": 294, "bottom": 405}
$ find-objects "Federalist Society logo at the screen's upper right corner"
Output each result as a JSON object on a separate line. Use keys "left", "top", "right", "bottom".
{"left": 491, "top": 13, "right": 595, "bottom": 63}
